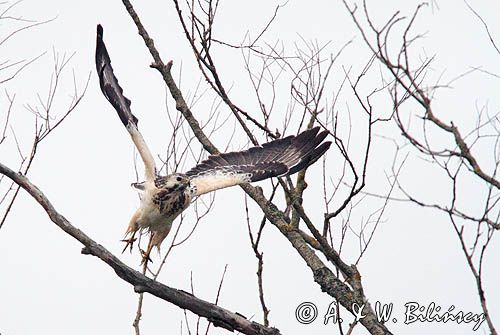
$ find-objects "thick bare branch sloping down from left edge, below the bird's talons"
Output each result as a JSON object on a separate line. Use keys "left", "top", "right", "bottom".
{"left": 0, "top": 163, "right": 280, "bottom": 335}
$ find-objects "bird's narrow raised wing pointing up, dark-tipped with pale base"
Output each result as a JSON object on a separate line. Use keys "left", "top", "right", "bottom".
{"left": 95, "top": 24, "right": 156, "bottom": 181}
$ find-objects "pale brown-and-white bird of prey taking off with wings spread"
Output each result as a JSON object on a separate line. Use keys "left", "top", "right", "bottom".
{"left": 95, "top": 25, "right": 331, "bottom": 262}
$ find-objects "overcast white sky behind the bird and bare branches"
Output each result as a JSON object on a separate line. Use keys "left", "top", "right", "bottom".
{"left": 0, "top": 0, "right": 500, "bottom": 335}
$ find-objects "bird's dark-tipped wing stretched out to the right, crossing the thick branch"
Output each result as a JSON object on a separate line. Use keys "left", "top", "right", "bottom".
{"left": 186, "top": 127, "right": 331, "bottom": 195}
